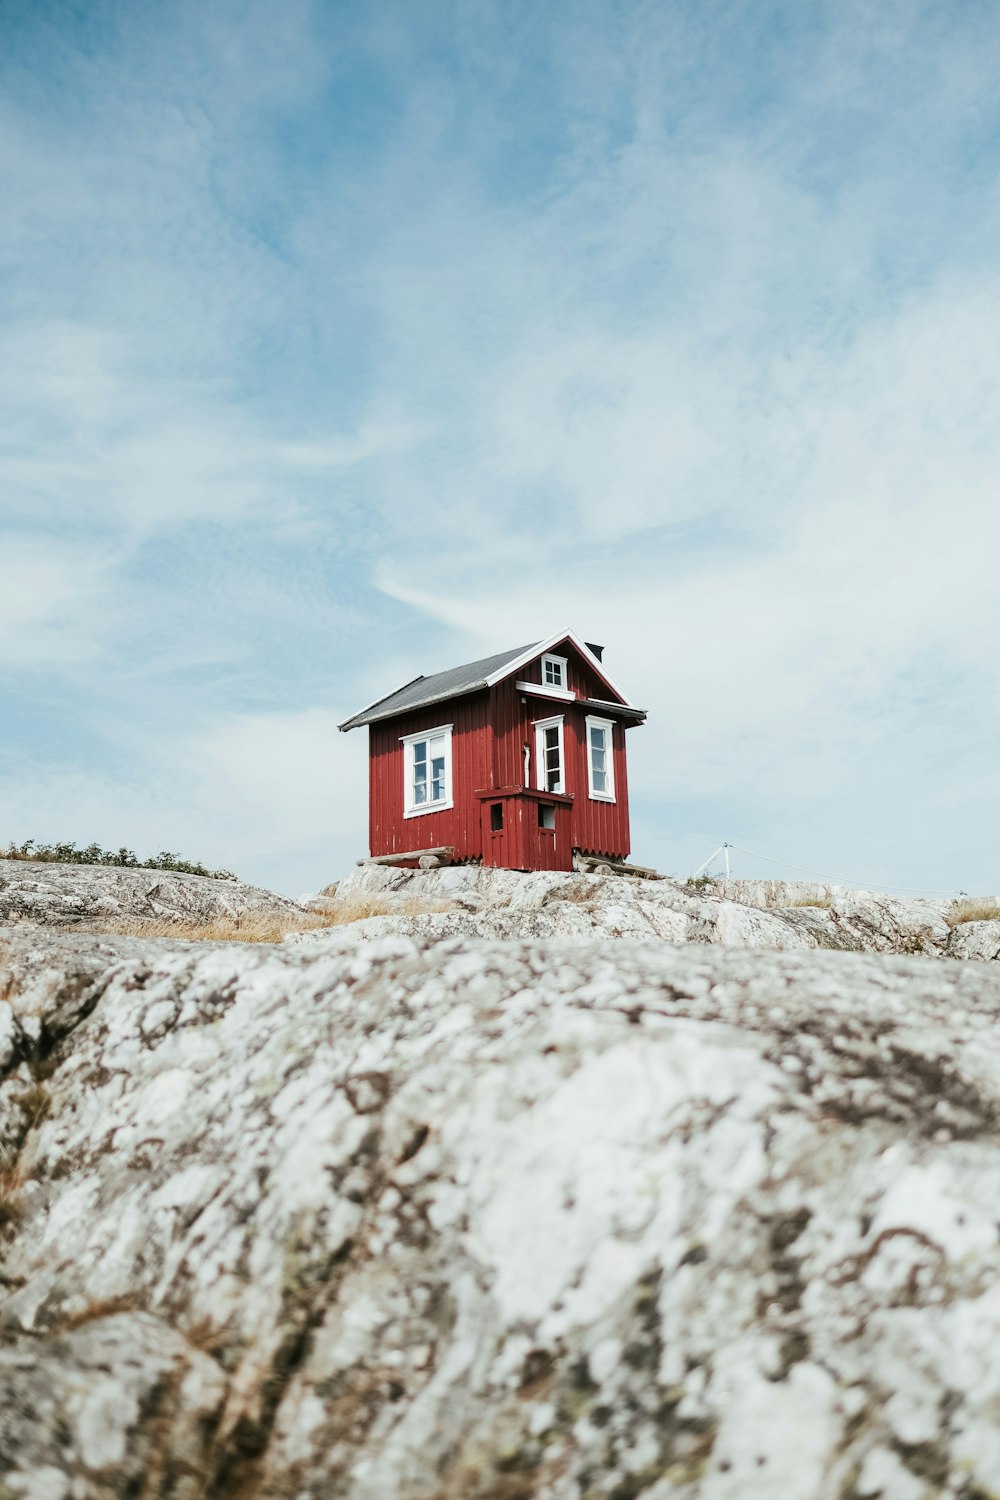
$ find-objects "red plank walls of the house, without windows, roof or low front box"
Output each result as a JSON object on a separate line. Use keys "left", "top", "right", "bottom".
{"left": 369, "top": 647, "right": 641, "bottom": 869}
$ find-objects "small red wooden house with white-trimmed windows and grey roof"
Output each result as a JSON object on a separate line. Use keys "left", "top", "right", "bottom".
{"left": 340, "top": 632, "right": 646, "bottom": 870}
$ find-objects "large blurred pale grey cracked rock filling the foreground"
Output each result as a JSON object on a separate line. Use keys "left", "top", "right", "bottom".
{"left": 0, "top": 929, "right": 1000, "bottom": 1500}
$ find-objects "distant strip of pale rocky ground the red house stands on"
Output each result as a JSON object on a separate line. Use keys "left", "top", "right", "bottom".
{"left": 7, "top": 860, "right": 1000, "bottom": 960}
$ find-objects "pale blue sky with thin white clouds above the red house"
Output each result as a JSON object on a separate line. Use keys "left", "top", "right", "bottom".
{"left": 0, "top": 0, "right": 1000, "bottom": 894}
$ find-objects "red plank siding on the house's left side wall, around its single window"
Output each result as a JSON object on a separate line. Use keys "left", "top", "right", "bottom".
{"left": 369, "top": 693, "right": 489, "bottom": 860}
